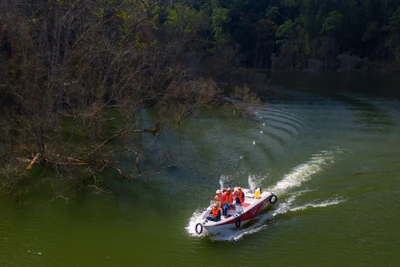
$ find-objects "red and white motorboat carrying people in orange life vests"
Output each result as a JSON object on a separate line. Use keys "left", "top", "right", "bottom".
{"left": 195, "top": 188, "right": 278, "bottom": 235}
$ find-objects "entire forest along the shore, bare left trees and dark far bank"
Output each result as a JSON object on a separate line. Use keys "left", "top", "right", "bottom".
{"left": 0, "top": 0, "right": 400, "bottom": 201}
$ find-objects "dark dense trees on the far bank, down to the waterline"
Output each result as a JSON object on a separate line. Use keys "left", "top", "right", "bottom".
{"left": 170, "top": 0, "right": 400, "bottom": 71}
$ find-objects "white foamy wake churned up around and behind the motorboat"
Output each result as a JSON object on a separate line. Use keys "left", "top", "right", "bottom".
{"left": 186, "top": 149, "right": 345, "bottom": 241}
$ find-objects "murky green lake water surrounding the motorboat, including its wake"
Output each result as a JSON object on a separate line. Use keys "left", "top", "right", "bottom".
{"left": 0, "top": 73, "right": 400, "bottom": 267}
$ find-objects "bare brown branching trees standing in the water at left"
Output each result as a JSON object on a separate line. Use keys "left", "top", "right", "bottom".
{"left": 0, "top": 0, "right": 260, "bottom": 200}
